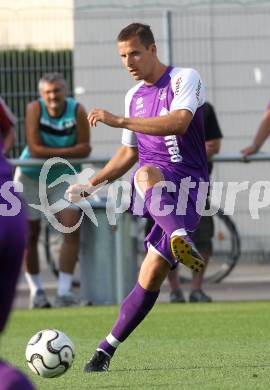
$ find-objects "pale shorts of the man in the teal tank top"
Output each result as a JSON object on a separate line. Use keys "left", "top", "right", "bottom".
{"left": 14, "top": 167, "right": 80, "bottom": 221}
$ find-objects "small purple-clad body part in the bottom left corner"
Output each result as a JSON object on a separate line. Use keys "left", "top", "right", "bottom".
{"left": 0, "top": 361, "right": 35, "bottom": 390}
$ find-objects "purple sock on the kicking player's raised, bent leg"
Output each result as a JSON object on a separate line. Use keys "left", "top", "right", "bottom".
{"left": 144, "top": 188, "right": 185, "bottom": 237}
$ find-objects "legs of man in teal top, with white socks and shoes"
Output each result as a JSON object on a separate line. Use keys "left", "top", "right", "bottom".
{"left": 15, "top": 171, "right": 80, "bottom": 308}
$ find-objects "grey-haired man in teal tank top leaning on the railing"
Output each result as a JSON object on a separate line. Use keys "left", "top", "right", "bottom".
{"left": 16, "top": 73, "right": 91, "bottom": 308}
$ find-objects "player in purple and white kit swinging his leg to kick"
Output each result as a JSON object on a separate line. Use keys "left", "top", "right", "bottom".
{"left": 68, "top": 23, "right": 208, "bottom": 372}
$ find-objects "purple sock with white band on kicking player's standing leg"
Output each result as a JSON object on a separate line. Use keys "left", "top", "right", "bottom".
{"left": 98, "top": 282, "right": 159, "bottom": 356}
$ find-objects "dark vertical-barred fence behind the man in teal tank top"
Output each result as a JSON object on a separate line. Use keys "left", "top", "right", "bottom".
{"left": 0, "top": 49, "right": 73, "bottom": 157}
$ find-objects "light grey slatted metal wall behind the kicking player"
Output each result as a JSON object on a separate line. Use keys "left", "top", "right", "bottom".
{"left": 74, "top": 0, "right": 270, "bottom": 261}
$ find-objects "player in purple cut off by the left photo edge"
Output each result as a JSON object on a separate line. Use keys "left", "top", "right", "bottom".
{"left": 0, "top": 99, "right": 34, "bottom": 390}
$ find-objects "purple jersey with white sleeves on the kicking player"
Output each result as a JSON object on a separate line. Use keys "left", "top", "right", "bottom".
{"left": 122, "top": 67, "right": 208, "bottom": 181}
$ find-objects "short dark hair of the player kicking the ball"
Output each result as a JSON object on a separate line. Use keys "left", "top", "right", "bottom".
{"left": 117, "top": 23, "right": 155, "bottom": 49}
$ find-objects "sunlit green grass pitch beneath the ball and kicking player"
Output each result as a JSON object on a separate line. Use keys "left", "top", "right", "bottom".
{"left": 1, "top": 302, "right": 270, "bottom": 390}
